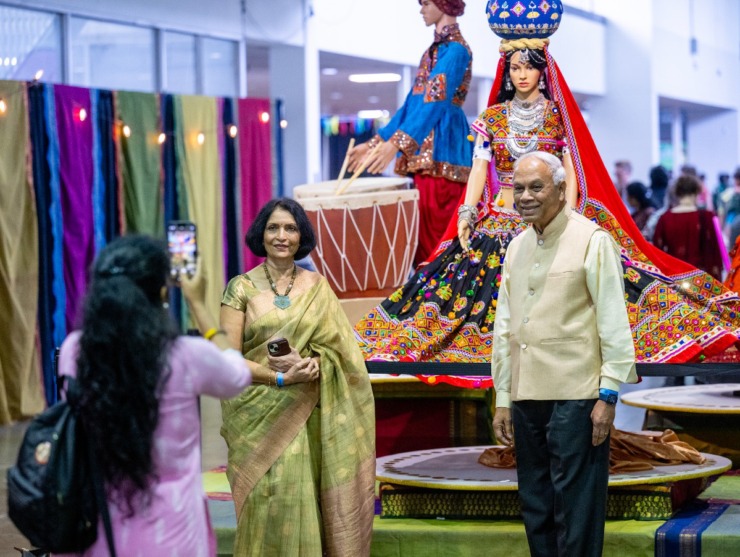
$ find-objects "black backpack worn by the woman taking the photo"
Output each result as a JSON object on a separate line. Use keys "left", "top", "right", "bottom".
{"left": 8, "top": 378, "right": 115, "bottom": 556}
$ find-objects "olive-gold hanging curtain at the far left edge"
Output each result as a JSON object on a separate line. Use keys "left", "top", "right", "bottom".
{"left": 0, "top": 81, "right": 44, "bottom": 424}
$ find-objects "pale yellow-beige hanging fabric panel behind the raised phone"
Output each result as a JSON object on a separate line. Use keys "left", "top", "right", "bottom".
{"left": 175, "top": 95, "right": 225, "bottom": 315}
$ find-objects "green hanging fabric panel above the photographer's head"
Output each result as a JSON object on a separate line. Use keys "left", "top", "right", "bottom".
{"left": 115, "top": 91, "right": 163, "bottom": 237}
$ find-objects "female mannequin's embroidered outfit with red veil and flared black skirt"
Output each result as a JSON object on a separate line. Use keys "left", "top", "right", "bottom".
{"left": 355, "top": 46, "right": 740, "bottom": 388}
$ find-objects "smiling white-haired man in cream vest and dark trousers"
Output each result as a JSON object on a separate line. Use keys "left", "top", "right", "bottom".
{"left": 492, "top": 151, "right": 636, "bottom": 557}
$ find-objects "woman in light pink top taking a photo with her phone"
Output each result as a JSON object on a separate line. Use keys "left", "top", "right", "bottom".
{"left": 59, "top": 236, "right": 251, "bottom": 557}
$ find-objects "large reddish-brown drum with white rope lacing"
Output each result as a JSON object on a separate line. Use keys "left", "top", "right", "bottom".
{"left": 293, "top": 178, "right": 419, "bottom": 298}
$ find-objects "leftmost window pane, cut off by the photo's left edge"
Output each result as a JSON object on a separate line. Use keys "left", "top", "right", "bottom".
{"left": 0, "top": 6, "right": 63, "bottom": 82}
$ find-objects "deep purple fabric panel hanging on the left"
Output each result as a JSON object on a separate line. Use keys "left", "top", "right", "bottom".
{"left": 54, "top": 85, "right": 95, "bottom": 331}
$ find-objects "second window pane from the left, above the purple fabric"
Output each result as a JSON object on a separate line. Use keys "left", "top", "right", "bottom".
{"left": 70, "top": 17, "right": 156, "bottom": 91}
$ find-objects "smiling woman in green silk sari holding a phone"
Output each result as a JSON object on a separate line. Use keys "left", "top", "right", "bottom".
{"left": 221, "top": 199, "right": 375, "bottom": 557}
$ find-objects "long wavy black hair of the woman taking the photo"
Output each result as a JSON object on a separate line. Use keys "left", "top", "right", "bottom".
{"left": 77, "top": 236, "right": 177, "bottom": 516}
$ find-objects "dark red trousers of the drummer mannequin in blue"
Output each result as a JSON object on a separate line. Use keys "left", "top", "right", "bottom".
{"left": 414, "top": 174, "right": 465, "bottom": 266}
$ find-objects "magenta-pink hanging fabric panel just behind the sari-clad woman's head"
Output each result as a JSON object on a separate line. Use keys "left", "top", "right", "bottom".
{"left": 239, "top": 99, "right": 272, "bottom": 270}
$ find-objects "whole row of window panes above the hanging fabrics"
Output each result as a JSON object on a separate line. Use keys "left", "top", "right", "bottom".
{"left": 0, "top": 5, "right": 240, "bottom": 96}
